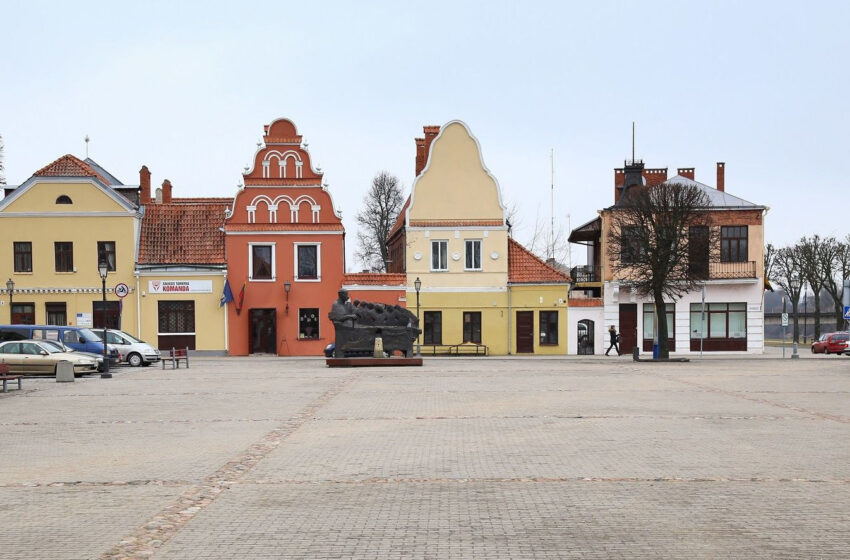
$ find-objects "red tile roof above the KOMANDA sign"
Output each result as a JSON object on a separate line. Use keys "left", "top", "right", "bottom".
{"left": 139, "top": 199, "right": 229, "bottom": 264}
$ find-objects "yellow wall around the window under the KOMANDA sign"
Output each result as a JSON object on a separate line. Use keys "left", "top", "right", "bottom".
{"left": 134, "top": 272, "right": 225, "bottom": 351}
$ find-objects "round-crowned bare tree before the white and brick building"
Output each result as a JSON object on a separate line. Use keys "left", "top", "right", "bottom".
{"left": 603, "top": 183, "right": 719, "bottom": 359}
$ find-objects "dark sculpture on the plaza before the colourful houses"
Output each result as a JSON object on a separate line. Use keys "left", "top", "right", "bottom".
{"left": 328, "top": 290, "right": 422, "bottom": 358}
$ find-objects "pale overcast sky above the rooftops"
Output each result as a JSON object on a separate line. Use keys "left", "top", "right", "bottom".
{"left": 0, "top": 0, "right": 850, "bottom": 270}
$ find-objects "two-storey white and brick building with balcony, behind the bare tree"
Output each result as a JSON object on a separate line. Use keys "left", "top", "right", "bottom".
{"left": 570, "top": 161, "right": 767, "bottom": 354}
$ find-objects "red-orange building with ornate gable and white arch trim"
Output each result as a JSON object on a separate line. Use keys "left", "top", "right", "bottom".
{"left": 224, "top": 119, "right": 345, "bottom": 356}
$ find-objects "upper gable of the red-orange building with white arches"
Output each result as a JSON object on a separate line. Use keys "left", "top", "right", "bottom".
{"left": 247, "top": 119, "right": 323, "bottom": 187}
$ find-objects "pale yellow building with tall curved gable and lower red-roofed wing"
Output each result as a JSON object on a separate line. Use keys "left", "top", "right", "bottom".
{"left": 389, "top": 121, "right": 568, "bottom": 355}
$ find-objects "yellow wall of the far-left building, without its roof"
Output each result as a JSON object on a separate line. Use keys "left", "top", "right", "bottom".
{"left": 0, "top": 179, "right": 139, "bottom": 328}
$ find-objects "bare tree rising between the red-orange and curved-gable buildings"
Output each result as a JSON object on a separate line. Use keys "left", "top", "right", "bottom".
{"left": 355, "top": 171, "right": 404, "bottom": 271}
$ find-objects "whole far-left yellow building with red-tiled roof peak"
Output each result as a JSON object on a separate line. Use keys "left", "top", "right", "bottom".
{"left": 0, "top": 155, "right": 141, "bottom": 334}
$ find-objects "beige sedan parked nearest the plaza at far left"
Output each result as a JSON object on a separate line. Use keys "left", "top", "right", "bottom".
{"left": 0, "top": 340, "right": 97, "bottom": 375}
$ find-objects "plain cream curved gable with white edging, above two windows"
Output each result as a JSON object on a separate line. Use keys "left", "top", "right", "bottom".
{"left": 408, "top": 121, "right": 504, "bottom": 226}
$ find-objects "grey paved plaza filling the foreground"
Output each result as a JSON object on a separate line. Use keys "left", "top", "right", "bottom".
{"left": 0, "top": 349, "right": 850, "bottom": 560}
